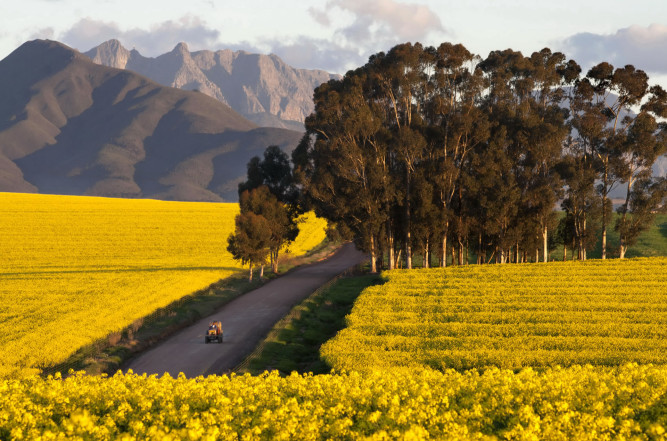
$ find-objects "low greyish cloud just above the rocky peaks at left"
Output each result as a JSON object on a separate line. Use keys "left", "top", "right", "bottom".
{"left": 59, "top": 16, "right": 220, "bottom": 56}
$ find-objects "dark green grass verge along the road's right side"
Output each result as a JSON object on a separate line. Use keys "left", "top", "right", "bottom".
{"left": 235, "top": 274, "right": 381, "bottom": 375}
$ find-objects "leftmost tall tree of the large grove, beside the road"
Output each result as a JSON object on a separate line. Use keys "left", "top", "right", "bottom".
{"left": 293, "top": 68, "right": 392, "bottom": 272}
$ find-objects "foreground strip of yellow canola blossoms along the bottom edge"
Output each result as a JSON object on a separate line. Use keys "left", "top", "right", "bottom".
{"left": 0, "top": 364, "right": 667, "bottom": 441}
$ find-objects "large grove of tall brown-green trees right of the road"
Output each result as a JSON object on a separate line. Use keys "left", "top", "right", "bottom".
{"left": 292, "top": 43, "right": 667, "bottom": 271}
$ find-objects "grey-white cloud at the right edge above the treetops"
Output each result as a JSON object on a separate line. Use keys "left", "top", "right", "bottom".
{"left": 563, "top": 24, "right": 667, "bottom": 74}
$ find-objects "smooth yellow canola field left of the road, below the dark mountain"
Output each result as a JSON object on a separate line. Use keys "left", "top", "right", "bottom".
{"left": 0, "top": 193, "right": 324, "bottom": 377}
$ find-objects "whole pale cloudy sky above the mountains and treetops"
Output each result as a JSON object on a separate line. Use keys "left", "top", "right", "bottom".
{"left": 0, "top": 0, "right": 667, "bottom": 88}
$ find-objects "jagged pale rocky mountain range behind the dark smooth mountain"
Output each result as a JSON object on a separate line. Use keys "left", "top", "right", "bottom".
{"left": 85, "top": 40, "right": 340, "bottom": 131}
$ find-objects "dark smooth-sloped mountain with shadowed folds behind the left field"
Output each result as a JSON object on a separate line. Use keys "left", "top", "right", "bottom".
{"left": 0, "top": 40, "right": 302, "bottom": 201}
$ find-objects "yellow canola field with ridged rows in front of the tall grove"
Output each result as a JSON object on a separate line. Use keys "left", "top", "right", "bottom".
{"left": 321, "top": 257, "right": 667, "bottom": 371}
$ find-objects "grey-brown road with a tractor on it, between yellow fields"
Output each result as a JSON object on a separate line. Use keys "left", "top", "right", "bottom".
{"left": 125, "top": 244, "right": 365, "bottom": 378}
